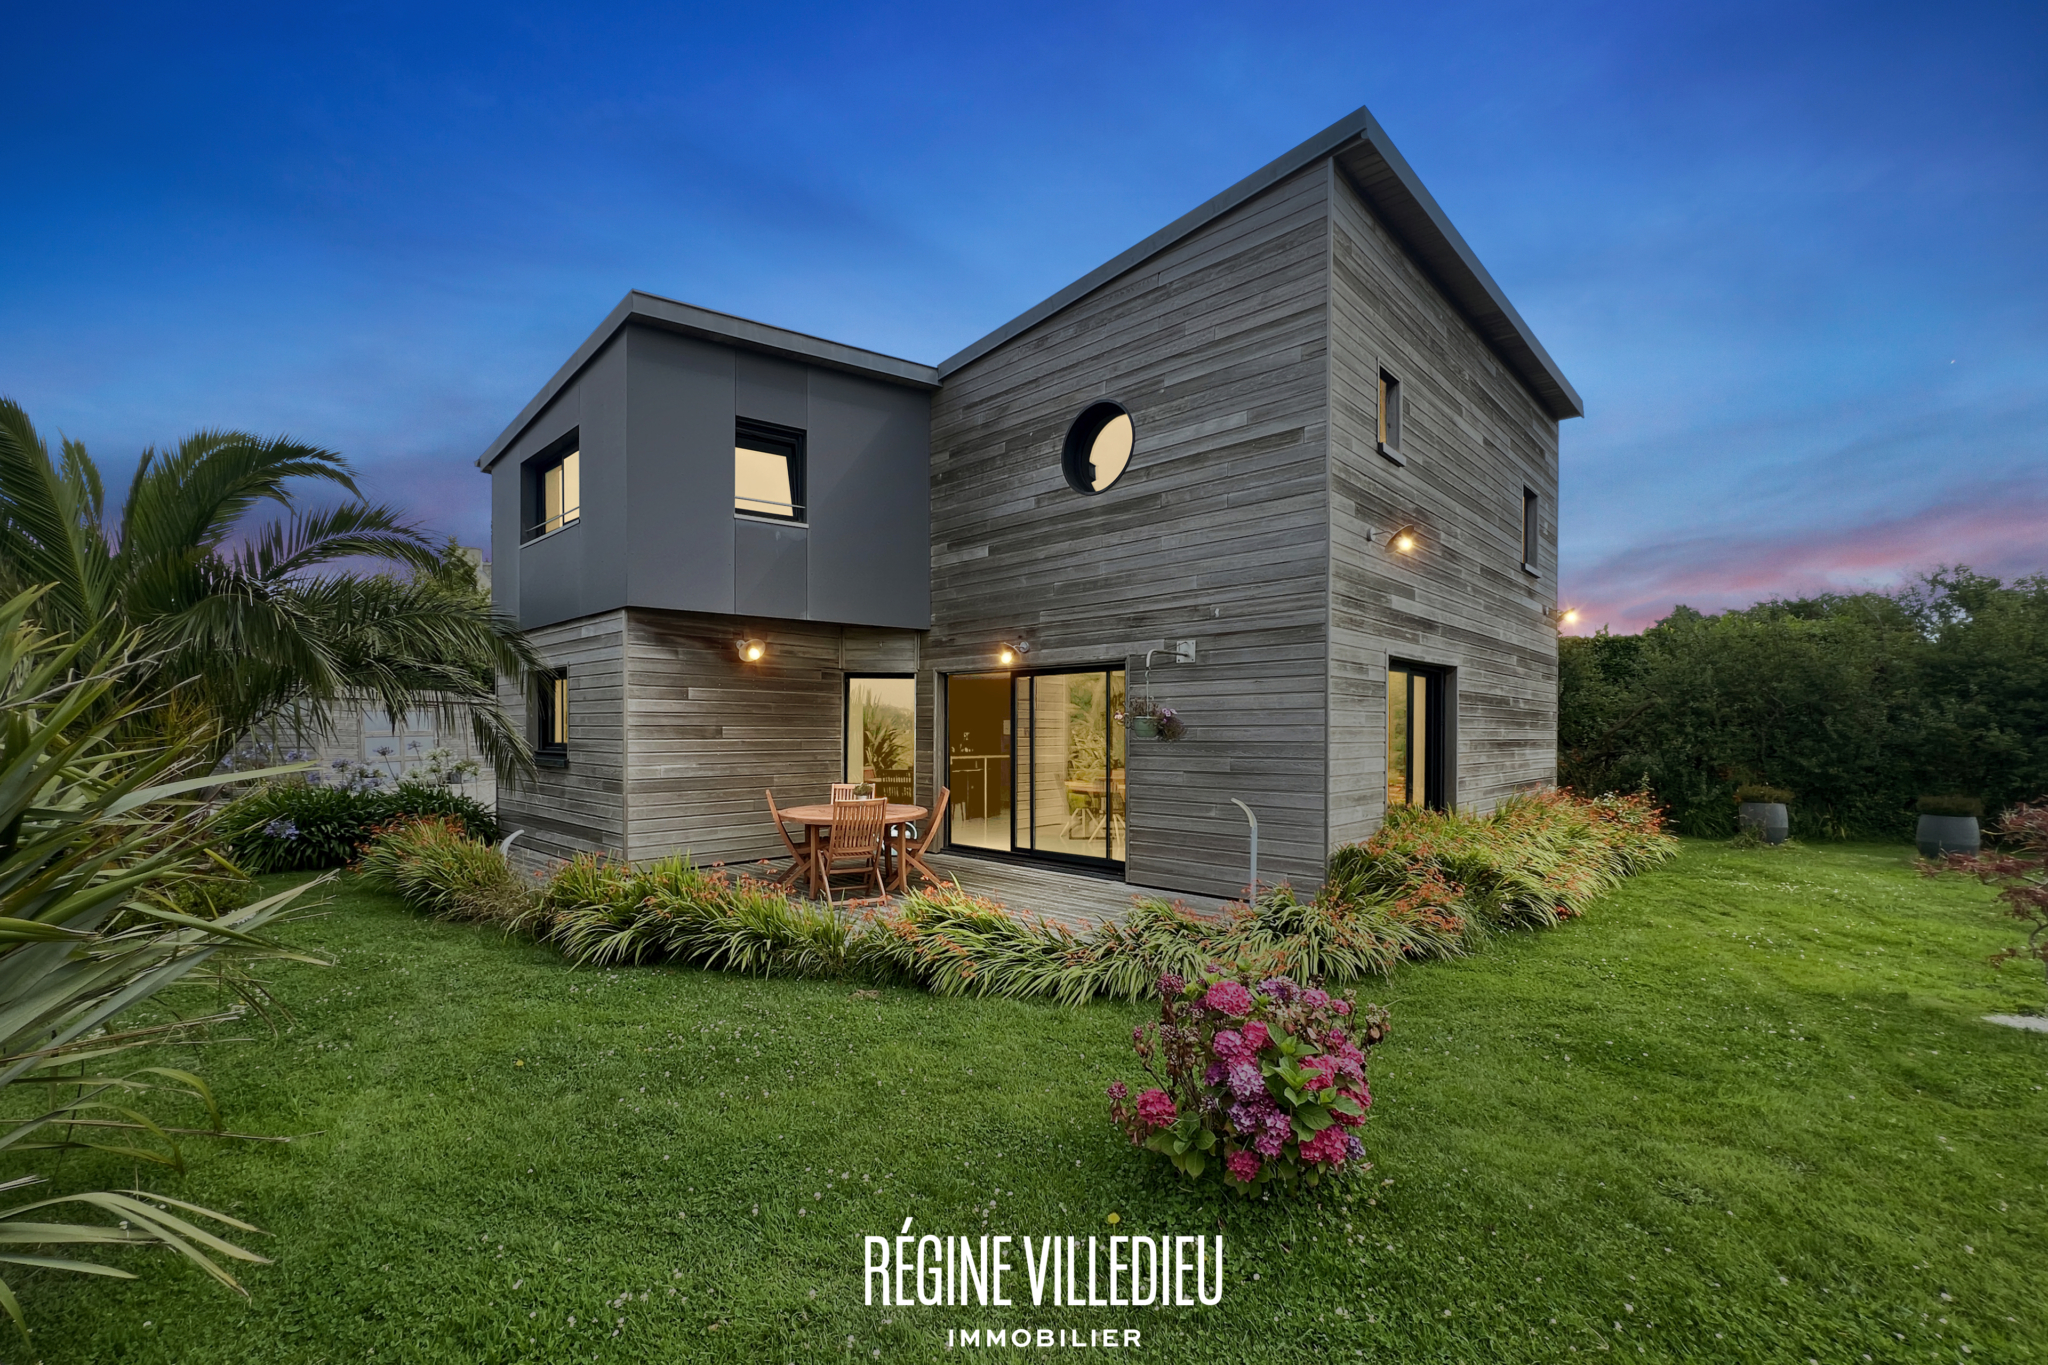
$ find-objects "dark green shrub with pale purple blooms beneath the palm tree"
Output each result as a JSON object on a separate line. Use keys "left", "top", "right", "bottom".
{"left": 221, "top": 780, "right": 498, "bottom": 872}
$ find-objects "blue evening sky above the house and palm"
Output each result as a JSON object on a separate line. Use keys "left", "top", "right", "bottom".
{"left": 0, "top": 0, "right": 2048, "bottom": 628}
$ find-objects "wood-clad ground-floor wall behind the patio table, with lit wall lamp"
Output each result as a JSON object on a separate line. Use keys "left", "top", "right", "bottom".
{"left": 625, "top": 610, "right": 918, "bottom": 864}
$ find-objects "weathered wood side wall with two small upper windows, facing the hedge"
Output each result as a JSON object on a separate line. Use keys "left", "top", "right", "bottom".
{"left": 1329, "top": 156, "right": 1556, "bottom": 845}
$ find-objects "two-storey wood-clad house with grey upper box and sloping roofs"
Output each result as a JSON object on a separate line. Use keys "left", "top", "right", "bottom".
{"left": 479, "top": 111, "right": 1581, "bottom": 894}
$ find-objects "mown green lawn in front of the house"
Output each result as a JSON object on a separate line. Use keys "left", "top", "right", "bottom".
{"left": 28, "top": 843, "right": 2048, "bottom": 1365}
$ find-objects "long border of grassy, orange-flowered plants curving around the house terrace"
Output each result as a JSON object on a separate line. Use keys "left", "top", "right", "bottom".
{"left": 362, "top": 792, "right": 1675, "bottom": 1005}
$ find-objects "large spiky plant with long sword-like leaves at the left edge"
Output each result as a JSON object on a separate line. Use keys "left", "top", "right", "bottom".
{"left": 0, "top": 589, "right": 323, "bottom": 1332}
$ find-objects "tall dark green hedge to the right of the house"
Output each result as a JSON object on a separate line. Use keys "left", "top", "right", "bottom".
{"left": 1559, "top": 569, "right": 2048, "bottom": 839}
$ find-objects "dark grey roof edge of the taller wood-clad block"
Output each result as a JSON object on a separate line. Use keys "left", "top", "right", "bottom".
{"left": 936, "top": 106, "right": 1585, "bottom": 420}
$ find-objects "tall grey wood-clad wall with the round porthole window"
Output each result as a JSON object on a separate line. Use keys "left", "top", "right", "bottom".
{"left": 920, "top": 168, "right": 1329, "bottom": 896}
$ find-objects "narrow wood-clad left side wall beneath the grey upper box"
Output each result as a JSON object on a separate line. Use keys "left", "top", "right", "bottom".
{"left": 498, "top": 612, "right": 627, "bottom": 868}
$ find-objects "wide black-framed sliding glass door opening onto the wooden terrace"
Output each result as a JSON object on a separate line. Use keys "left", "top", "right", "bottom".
{"left": 946, "top": 669, "right": 1126, "bottom": 866}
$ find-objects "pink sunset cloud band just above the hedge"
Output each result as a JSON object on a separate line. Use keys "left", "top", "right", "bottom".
{"left": 1563, "top": 493, "right": 2048, "bottom": 634}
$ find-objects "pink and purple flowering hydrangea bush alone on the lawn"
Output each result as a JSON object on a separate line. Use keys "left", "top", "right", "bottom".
{"left": 1110, "top": 974, "right": 1386, "bottom": 1195}
